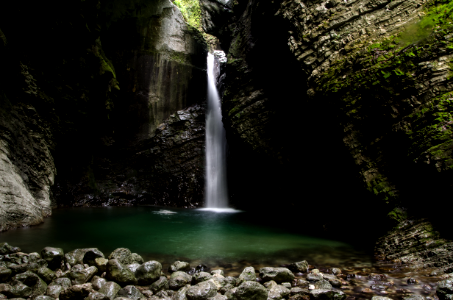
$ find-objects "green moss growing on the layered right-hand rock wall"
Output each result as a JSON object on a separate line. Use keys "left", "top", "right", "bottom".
{"left": 317, "top": 0, "right": 453, "bottom": 210}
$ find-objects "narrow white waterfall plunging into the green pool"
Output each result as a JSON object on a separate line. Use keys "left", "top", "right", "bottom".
{"left": 205, "top": 53, "right": 228, "bottom": 209}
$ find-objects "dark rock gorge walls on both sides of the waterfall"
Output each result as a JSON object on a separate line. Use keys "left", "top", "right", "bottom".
{"left": 0, "top": 0, "right": 453, "bottom": 269}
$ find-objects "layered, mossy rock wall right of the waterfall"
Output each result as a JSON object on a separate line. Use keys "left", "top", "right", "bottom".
{"left": 208, "top": 0, "right": 453, "bottom": 225}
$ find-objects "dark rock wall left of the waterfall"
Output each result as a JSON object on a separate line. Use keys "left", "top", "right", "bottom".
{"left": 0, "top": 0, "right": 206, "bottom": 231}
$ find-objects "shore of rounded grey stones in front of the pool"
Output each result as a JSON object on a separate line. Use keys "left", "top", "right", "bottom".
{"left": 0, "top": 243, "right": 453, "bottom": 300}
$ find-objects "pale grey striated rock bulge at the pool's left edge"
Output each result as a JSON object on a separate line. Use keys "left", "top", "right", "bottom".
{"left": 0, "top": 99, "right": 55, "bottom": 231}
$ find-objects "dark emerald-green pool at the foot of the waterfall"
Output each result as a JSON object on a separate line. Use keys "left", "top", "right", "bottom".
{"left": 0, "top": 206, "right": 371, "bottom": 274}
